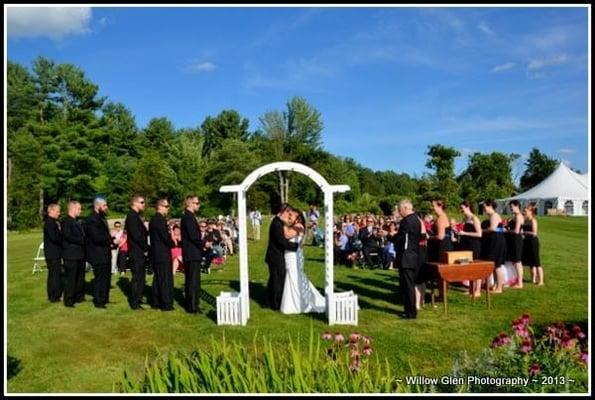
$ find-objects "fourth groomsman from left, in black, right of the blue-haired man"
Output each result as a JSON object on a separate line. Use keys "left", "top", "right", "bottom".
{"left": 124, "top": 195, "right": 149, "bottom": 310}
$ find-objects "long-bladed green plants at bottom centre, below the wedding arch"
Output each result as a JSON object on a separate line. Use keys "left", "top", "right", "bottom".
{"left": 118, "top": 331, "right": 434, "bottom": 393}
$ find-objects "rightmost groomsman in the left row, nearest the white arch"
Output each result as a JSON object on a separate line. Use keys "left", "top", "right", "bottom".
{"left": 181, "top": 195, "right": 203, "bottom": 314}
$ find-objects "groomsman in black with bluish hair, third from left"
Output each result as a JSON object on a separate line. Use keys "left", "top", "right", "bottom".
{"left": 85, "top": 197, "right": 112, "bottom": 308}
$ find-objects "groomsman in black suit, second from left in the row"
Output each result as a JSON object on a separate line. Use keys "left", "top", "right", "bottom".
{"left": 62, "top": 201, "right": 85, "bottom": 307}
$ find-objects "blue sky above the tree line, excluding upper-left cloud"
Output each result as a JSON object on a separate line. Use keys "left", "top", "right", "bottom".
{"left": 7, "top": 7, "right": 590, "bottom": 175}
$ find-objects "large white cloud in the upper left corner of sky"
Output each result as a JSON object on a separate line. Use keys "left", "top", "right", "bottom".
{"left": 6, "top": 7, "right": 91, "bottom": 40}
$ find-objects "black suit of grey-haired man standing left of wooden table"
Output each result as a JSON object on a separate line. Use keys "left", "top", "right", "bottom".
{"left": 393, "top": 214, "right": 421, "bottom": 318}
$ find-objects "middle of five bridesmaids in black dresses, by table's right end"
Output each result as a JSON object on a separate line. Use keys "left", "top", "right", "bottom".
{"left": 482, "top": 200, "right": 506, "bottom": 293}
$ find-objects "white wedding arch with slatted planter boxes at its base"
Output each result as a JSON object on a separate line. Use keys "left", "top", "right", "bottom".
{"left": 217, "top": 161, "right": 358, "bottom": 325}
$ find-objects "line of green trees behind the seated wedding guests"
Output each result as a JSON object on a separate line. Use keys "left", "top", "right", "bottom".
{"left": 6, "top": 57, "right": 557, "bottom": 229}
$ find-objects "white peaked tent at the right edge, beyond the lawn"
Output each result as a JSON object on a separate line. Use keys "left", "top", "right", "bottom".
{"left": 498, "top": 162, "right": 589, "bottom": 215}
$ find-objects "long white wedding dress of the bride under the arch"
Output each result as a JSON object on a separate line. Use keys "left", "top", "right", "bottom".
{"left": 281, "top": 237, "right": 326, "bottom": 314}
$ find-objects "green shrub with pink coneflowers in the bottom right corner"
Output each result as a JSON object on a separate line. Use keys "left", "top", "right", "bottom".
{"left": 448, "top": 314, "right": 588, "bottom": 393}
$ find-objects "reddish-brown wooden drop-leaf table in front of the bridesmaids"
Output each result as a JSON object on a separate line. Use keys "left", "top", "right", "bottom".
{"left": 428, "top": 260, "right": 494, "bottom": 315}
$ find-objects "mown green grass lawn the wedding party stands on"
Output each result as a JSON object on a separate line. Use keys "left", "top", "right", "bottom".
{"left": 6, "top": 217, "right": 589, "bottom": 393}
